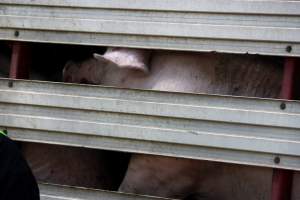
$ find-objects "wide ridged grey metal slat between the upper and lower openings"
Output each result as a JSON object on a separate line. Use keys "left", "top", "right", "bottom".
{"left": 0, "top": 79, "right": 300, "bottom": 170}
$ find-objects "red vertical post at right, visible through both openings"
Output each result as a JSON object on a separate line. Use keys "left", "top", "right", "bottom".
{"left": 272, "top": 58, "right": 296, "bottom": 200}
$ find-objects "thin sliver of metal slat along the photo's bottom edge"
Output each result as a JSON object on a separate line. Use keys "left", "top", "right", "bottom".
{"left": 39, "top": 183, "right": 168, "bottom": 200}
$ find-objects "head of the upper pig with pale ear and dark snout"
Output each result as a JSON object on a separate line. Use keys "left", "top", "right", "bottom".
{"left": 63, "top": 48, "right": 151, "bottom": 87}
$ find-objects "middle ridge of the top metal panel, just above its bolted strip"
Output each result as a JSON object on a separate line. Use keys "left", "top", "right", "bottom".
{"left": 0, "top": 15, "right": 300, "bottom": 43}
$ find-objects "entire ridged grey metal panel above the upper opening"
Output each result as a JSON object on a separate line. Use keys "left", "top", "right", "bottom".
{"left": 0, "top": 0, "right": 300, "bottom": 56}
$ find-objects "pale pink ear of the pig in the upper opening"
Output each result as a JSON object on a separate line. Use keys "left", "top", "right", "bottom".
{"left": 94, "top": 48, "right": 151, "bottom": 73}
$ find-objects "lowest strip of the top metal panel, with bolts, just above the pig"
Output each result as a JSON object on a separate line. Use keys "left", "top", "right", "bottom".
{"left": 0, "top": 29, "right": 300, "bottom": 56}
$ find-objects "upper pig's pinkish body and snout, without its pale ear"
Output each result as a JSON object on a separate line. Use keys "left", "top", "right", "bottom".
{"left": 63, "top": 50, "right": 282, "bottom": 98}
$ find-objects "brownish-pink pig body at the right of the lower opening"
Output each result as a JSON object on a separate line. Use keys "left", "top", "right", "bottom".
{"left": 119, "top": 154, "right": 272, "bottom": 200}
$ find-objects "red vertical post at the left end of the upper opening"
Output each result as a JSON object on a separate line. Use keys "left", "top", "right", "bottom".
{"left": 9, "top": 42, "right": 31, "bottom": 79}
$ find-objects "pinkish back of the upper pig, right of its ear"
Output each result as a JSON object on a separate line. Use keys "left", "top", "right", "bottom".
{"left": 151, "top": 51, "right": 282, "bottom": 98}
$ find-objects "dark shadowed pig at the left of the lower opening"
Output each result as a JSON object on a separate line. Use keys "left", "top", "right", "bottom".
{"left": 22, "top": 143, "right": 128, "bottom": 190}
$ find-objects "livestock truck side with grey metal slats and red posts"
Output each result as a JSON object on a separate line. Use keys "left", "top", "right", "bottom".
{"left": 0, "top": 0, "right": 300, "bottom": 200}
